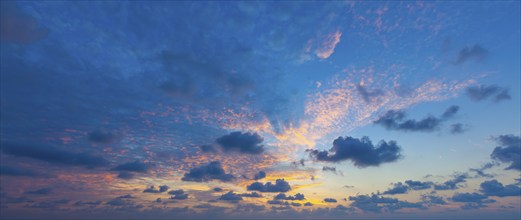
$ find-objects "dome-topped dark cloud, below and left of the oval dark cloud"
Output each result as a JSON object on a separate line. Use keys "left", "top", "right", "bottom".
{"left": 181, "top": 161, "right": 234, "bottom": 182}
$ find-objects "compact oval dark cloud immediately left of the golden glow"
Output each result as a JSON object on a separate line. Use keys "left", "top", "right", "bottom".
{"left": 215, "top": 131, "right": 264, "bottom": 154}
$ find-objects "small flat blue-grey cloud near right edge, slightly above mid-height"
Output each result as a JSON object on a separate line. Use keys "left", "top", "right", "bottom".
{"left": 465, "top": 85, "right": 511, "bottom": 102}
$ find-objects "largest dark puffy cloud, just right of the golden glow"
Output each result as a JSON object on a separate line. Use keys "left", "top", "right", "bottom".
{"left": 307, "top": 137, "right": 401, "bottom": 168}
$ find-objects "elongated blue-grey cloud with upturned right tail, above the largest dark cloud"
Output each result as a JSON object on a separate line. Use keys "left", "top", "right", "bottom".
{"left": 373, "top": 105, "right": 459, "bottom": 132}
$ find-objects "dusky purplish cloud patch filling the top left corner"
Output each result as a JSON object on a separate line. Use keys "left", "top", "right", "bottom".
{"left": 0, "top": 1, "right": 48, "bottom": 44}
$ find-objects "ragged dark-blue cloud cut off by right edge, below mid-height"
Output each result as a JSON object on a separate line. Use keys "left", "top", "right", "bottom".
{"left": 490, "top": 134, "right": 521, "bottom": 171}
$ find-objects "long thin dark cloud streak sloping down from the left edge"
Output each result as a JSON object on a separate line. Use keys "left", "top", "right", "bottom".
{"left": 1, "top": 142, "right": 108, "bottom": 168}
